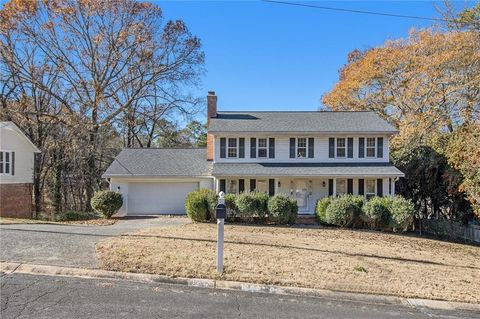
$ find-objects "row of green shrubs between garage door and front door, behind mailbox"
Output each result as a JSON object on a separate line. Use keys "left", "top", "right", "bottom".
{"left": 185, "top": 189, "right": 298, "bottom": 224}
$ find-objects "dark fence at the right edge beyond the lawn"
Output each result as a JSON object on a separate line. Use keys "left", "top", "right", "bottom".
{"left": 421, "top": 219, "right": 480, "bottom": 243}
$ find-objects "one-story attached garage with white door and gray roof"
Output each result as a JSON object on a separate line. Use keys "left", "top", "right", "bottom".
{"left": 103, "top": 148, "right": 213, "bottom": 216}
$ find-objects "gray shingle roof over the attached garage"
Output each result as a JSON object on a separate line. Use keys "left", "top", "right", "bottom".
{"left": 103, "top": 148, "right": 212, "bottom": 177}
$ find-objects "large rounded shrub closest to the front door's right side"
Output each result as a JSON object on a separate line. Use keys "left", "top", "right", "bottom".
{"left": 325, "top": 194, "right": 363, "bottom": 227}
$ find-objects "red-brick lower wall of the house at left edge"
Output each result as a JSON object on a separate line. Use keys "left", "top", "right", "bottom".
{"left": 0, "top": 184, "right": 32, "bottom": 218}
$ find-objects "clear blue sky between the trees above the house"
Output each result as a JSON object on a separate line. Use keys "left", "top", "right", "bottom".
{"left": 155, "top": 1, "right": 472, "bottom": 111}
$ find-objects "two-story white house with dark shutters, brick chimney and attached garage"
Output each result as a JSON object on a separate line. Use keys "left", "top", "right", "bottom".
{"left": 104, "top": 92, "right": 404, "bottom": 215}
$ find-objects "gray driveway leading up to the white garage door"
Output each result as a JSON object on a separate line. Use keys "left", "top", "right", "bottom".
{"left": 0, "top": 217, "right": 188, "bottom": 268}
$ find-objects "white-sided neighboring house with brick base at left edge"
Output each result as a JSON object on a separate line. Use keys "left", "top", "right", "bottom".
{"left": 0, "top": 122, "right": 40, "bottom": 218}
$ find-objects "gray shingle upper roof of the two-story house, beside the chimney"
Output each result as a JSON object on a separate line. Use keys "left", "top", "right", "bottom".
{"left": 209, "top": 112, "right": 397, "bottom": 134}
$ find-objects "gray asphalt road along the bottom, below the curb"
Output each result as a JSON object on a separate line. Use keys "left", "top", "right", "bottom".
{"left": 0, "top": 273, "right": 479, "bottom": 319}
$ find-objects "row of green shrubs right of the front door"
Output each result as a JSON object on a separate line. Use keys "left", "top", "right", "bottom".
{"left": 315, "top": 194, "right": 414, "bottom": 231}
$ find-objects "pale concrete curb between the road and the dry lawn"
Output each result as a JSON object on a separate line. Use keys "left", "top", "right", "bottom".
{"left": 0, "top": 262, "right": 480, "bottom": 311}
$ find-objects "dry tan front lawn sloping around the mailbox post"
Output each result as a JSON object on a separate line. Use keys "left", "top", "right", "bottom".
{"left": 97, "top": 224, "right": 480, "bottom": 303}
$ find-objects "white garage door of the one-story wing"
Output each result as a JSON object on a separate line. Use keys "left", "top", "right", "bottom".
{"left": 127, "top": 182, "right": 198, "bottom": 215}
